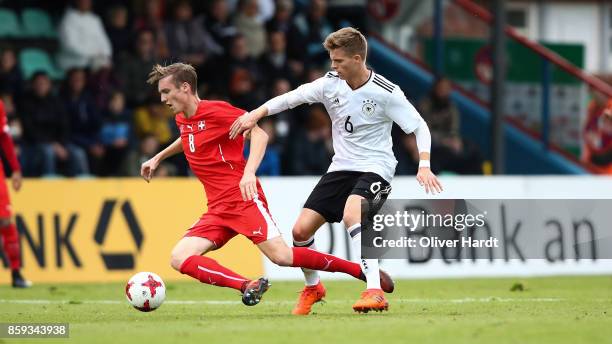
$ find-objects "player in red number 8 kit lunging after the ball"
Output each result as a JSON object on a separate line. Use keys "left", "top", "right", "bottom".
{"left": 141, "top": 63, "right": 393, "bottom": 306}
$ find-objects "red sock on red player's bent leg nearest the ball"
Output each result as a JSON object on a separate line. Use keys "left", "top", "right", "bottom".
{"left": 181, "top": 256, "right": 250, "bottom": 291}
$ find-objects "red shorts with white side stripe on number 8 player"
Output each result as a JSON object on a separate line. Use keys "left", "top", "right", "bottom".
{"left": 185, "top": 195, "right": 281, "bottom": 248}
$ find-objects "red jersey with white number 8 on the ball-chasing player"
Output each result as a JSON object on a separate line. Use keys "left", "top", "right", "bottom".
{"left": 175, "top": 100, "right": 265, "bottom": 209}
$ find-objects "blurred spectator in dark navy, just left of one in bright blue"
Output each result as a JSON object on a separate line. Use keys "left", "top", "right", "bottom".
{"left": 62, "top": 68, "right": 104, "bottom": 174}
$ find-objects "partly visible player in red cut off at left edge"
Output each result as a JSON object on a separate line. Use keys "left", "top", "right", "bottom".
{"left": 0, "top": 100, "right": 32, "bottom": 288}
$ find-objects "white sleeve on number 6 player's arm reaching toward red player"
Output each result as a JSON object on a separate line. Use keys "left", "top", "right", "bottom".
{"left": 264, "top": 76, "right": 327, "bottom": 115}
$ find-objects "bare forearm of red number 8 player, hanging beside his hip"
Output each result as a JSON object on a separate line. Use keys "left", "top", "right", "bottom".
{"left": 240, "top": 125, "right": 268, "bottom": 201}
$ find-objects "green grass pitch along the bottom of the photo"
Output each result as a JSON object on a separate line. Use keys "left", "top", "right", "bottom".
{"left": 0, "top": 276, "right": 612, "bottom": 344}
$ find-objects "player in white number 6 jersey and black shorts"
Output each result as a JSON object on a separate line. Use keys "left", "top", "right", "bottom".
{"left": 230, "top": 28, "right": 442, "bottom": 314}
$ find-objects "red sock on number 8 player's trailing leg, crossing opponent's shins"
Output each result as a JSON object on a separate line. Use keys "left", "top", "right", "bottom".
{"left": 292, "top": 247, "right": 361, "bottom": 279}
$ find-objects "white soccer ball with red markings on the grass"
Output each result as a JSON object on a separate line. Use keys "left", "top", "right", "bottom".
{"left": 125, "top": 272, "right": 166, "bottom": 312}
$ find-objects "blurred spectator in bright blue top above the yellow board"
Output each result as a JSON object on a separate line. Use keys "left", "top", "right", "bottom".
{"left": 100, "top": 92, "right": 131, "bottom": 176}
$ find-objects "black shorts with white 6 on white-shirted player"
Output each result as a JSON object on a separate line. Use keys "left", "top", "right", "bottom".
{"left": 304, "top": 171, "right": 391, "bottom": 223}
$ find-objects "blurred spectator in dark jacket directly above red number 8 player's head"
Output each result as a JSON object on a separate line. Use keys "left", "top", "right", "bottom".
{"left": 165, "top": 0, "right": 223, "bottom": 68}
